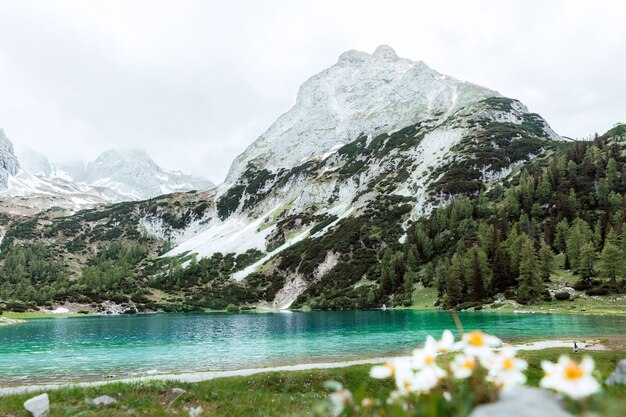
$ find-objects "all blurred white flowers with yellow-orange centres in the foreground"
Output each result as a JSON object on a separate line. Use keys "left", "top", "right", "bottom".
{"left": 328, "top": 330, "right": 600, "bottom": 416}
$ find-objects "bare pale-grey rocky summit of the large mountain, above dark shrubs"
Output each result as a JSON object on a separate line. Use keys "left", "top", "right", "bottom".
{"left": 226, "top": 45, "right": 499, "bottom": 182}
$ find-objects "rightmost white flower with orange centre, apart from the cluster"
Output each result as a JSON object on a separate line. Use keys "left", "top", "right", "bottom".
{"left": 540, "top": 355, "right": 600, "bottom": 399}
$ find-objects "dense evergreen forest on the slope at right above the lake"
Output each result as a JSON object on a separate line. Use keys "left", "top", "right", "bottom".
{"left": 379, "top": 139, "right": 626, "bottom": 306}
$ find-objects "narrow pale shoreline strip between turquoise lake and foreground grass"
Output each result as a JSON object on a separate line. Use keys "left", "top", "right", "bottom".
{"left": 0, "top": 340, "right": 610, "bottom": 397}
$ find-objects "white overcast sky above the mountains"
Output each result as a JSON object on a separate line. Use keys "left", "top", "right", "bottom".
{"left": 0, "top": 0, "right": 626, "bottom": 182}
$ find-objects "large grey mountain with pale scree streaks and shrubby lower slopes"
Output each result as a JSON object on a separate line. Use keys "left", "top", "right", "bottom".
{"left": 0, "top": 46, "right": 576, "bottom": 310}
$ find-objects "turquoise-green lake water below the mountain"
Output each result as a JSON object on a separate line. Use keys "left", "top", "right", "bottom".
{"left": 0, "top": 311, "right": 626, "bottom": 385}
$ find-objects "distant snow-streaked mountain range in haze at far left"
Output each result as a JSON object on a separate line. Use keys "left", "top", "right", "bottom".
{"left": 0, "top": 130, "right": 214, "bottom": 214}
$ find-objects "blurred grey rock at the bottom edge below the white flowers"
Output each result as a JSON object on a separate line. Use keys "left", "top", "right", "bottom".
{"left": 470, "top": 387, "right": 572, "bottom": 417}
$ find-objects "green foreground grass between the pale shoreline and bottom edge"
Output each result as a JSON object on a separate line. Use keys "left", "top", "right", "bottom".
{"left": 0, "top": 348, "right": 626, "bottom": 417}
